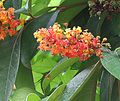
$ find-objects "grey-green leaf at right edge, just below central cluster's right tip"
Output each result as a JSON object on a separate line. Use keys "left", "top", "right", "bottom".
{"left": 101, "top": 50, "right": 120, "bottom": 80}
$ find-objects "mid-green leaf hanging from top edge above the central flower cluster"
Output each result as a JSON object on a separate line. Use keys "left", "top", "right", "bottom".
{"left": 57, "top": 0, "right": 88, "bottom": 23}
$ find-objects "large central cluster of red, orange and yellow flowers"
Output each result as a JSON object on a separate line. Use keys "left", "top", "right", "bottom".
{"left": 34, "top": 23, "right": 105, "bottom": 61}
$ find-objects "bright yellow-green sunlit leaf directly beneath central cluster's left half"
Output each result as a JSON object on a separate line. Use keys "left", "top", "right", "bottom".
{"left": 31, "top": 51, "right": 61, "bottom": 73}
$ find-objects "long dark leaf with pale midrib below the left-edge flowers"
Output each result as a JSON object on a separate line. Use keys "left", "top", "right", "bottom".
{"left": 0, "top": 30, "right": 22, "bottom": 101}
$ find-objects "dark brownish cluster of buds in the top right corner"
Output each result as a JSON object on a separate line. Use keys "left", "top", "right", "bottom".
{"left": 89, "top": 0, "right": 120, "bottom": 15}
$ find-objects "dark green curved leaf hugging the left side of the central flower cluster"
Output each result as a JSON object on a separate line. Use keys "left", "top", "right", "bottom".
{"left": 21, "top": 11, "right": 59, "bottom": 68}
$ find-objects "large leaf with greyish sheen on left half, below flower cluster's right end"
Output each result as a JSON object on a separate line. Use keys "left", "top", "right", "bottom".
{"left": 55, "top": 62, "right": 101, "bottom": 101}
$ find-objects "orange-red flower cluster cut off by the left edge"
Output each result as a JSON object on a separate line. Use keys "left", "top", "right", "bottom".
{"left": 0, "top": 1, "right": 21, "bottom": 40}
